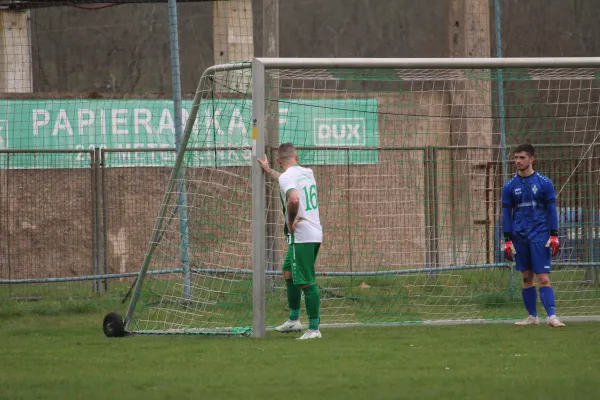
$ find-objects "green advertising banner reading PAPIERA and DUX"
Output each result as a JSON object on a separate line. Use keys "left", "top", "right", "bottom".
{"left": 0, "top": 99, "right": 378, "bottom": 168}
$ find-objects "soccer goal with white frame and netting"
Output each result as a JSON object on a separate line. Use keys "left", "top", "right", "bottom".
{"left": 104, "top": 58, "right": 600, "bottom": 337}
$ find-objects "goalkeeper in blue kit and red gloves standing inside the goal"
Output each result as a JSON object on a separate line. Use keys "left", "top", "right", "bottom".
{"left": 502, "top": 144, "right": 565, "bottom": 328}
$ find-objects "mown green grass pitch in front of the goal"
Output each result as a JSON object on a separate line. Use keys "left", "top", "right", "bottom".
{"left": 0, "top": 312, "right": 600, "bottom": 400}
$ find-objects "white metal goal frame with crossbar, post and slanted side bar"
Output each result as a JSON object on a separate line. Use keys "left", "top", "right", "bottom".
{"left": 125, "top": 57, "right": 600, "bottom": 338}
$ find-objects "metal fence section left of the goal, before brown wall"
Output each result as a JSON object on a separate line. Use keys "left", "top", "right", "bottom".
{"left": 0, "top": 149, "right": 166, "bottom": 308}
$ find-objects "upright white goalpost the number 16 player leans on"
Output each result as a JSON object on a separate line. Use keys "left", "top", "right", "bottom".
{"left": 252, "top": 58, "right": 266, "bottom": 338}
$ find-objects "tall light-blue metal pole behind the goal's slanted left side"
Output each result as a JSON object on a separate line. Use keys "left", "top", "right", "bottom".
{"left": 169, "top": 0, "right": 192, "bottom": 299}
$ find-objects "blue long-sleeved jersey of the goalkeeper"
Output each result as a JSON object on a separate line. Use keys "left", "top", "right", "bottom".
{"left": 502, "top": 172, "right": 558, "bottom": 242}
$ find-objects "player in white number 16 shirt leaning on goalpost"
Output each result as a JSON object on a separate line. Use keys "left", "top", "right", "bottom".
{"left": 258, "top": 143, "right": 323, "bottom": 340}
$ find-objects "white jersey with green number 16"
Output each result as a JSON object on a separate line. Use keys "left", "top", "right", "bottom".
{"left": 279, "top": 165, "right": 323, "bottom": 243}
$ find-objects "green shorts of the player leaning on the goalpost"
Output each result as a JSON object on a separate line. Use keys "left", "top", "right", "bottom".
{"left": 281, "top": 243, "right": 321, "bottom": 285}
